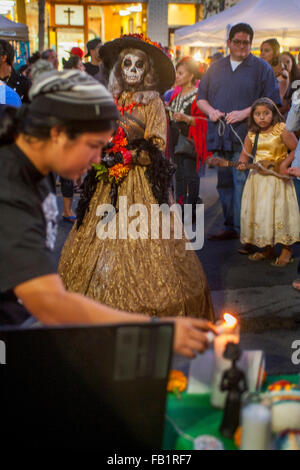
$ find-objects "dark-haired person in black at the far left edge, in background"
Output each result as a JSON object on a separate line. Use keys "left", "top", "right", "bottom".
{"left": 0, "top": 39, "right": 30, "bottom": 103}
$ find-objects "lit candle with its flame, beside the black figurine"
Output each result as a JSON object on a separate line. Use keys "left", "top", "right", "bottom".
{"left": 208, "top": 313, "right": 240, "bottom": 408}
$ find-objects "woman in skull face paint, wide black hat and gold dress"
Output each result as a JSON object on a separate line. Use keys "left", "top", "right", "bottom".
{"left": 59, "top": 35, "right": 214, "bottom": 320}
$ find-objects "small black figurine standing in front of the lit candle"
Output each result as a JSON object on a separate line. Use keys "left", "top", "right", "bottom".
{"left": 220, "top": 343, "right": 248, "bottom": 439}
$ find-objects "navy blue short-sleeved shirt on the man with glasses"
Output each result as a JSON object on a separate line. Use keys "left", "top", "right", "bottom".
{"left": 197, "top": 54, "right": 281, "bottom": 151}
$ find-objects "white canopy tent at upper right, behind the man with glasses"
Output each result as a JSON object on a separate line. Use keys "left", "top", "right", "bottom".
{"left": 175, "top": 0, "right": 300, "bottom": 47}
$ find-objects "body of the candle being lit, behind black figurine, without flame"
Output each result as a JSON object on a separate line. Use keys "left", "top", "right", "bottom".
{"left": 210, "top": 334, "right": 240, "bottom": 408}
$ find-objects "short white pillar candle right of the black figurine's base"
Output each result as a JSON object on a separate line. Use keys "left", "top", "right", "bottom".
{"left": 241, "top": 403, "right": 271, "bottom": 450}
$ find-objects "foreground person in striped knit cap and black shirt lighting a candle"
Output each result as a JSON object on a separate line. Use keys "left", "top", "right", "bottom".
{"left": 0, "top": 70, "right": 215, "bottom": 357}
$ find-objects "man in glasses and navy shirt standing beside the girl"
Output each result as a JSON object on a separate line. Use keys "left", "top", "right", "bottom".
{"left": 197, "top": 23, "right": 281, "bottom": 246}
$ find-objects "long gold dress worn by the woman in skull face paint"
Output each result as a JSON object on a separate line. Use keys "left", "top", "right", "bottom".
{"left": 59, "top": 92, "right": 214, "bottom": 320}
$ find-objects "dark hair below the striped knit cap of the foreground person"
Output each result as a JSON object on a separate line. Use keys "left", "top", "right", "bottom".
{"left": 0, "top": 104, "right": 116, "bottom": 146}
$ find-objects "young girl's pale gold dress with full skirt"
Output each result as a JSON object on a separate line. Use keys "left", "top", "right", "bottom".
{"left": 241, "top": 123, "right": 300, "bottom": 248}
